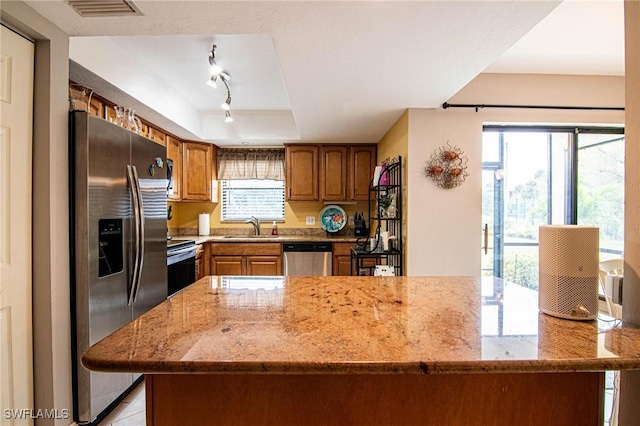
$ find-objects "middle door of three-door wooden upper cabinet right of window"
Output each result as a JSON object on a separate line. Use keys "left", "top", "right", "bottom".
{"left": 320, "top": 145, "right": 349, "bottom": 201}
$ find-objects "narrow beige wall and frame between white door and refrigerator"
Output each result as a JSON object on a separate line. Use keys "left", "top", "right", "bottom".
{"left": 0, "top": 2, "right": 72, "bottom": 426}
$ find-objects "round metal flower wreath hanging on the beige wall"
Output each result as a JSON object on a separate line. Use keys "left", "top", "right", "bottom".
{"left": 424, "top": 141, "right": 469, "bottom": 189}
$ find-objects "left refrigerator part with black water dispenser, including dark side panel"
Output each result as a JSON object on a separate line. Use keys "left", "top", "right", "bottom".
{"left": 71, "top": 112, "right": 133, "bottom": 422}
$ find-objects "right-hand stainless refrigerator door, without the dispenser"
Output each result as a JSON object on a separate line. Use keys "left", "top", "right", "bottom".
{"left": 131, "top": 133, "right": 168, "bottom": 318}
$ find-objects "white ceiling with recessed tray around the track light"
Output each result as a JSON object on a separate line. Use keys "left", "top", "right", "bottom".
{"left": 26, "top": 0, "right": 624, "bottom": 146}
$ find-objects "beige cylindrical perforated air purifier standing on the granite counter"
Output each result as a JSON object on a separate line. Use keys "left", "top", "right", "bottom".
{"left": 538, "top": 225, "right": 600, "bottom": 321}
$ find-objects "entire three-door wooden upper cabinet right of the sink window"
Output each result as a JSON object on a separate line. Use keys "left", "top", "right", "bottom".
{"left": 286, "top": 145, "right": 377, "bottom": 202}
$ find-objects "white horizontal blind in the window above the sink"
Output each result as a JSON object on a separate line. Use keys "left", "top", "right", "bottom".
{"left": 221, "top": 179, "right": 284, "bottom": 222}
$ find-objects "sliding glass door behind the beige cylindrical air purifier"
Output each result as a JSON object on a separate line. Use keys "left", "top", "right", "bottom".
{"left": 482, "top": 126, "right": 624, "bottom": 289}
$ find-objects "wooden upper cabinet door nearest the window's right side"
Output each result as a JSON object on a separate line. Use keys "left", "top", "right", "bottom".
{"left": 286, "top": 145, "right": 318, "bottom": 201}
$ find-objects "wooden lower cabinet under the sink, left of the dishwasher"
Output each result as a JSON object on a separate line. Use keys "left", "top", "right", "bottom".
{"left": 210, "top": 243, "right": 282, "bottom": 275}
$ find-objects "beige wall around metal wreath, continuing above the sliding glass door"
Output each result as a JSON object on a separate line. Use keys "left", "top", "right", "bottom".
{"left": 407, "top": 74, "right": 624, "bottom": 276}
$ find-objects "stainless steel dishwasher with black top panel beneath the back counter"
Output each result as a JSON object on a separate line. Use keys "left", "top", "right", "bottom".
{"left": 282, "top": 242, "right": 333, "bottom": 277}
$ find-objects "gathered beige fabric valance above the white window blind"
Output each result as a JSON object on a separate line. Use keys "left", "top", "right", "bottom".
{"left": 217, "top": 148, "right": 284, "bottom": 180}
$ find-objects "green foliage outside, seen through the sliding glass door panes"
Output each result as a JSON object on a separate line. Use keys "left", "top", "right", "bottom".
{"left": 483, "top": 131, "right": 624, "bottom": 290}
